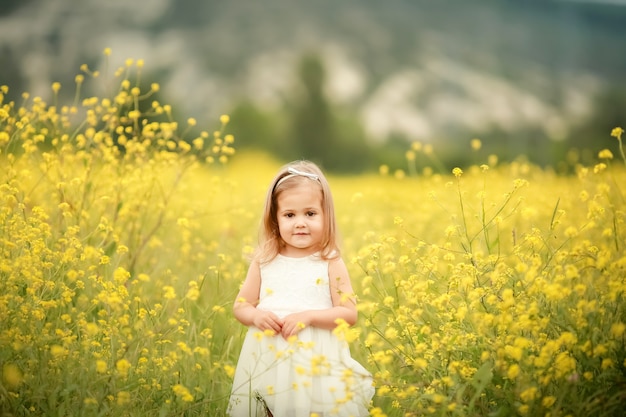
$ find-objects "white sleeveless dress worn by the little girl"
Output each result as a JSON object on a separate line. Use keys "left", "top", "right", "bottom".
{"left": 228, "top": 255, "right": 374, "bottom": 417}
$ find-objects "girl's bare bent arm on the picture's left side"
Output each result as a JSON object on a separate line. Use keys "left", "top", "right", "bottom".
{"left": 233, "top": 260, "right": 283, "bottom": 334}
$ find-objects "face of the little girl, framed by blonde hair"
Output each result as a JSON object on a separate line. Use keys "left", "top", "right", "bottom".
{"left": 276, "top": 181, "right": 324, "bottom": 257}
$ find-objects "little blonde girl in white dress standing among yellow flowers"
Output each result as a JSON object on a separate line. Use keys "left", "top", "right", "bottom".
{"left": 228, "top": 161, "right": 374, "bottom": 417}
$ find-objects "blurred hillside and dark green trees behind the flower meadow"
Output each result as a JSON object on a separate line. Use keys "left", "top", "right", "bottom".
{"left": 0, "top": 0, "right": 626, "bottom": 172}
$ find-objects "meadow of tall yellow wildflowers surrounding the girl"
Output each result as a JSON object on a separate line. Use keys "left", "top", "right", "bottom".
{"left": 0, "top": 50, "right": 626, "bottom": 417}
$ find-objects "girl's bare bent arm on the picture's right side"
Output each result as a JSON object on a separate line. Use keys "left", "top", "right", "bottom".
{"left": 282, "top": 258, "right": 357, "bottom": 338}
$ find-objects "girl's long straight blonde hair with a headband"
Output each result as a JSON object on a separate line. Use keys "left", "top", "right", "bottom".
{"left": 255, "top": 161, "right": 339, "bottom": 263}
